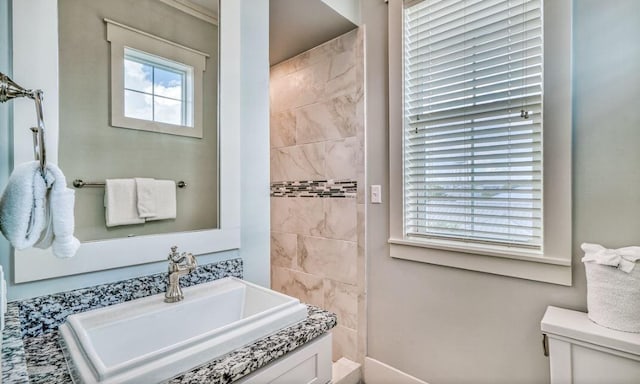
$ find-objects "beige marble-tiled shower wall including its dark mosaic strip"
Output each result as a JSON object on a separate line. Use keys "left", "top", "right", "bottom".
{"left": 271, "top": 29, "right": 366, "bottom": 362}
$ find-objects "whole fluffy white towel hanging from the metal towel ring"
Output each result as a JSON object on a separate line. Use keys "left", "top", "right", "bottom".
{"left": 0, "top": 161, "right": 80, "bottom": 257}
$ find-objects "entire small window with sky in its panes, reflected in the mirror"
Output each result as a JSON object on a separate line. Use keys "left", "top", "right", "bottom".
{"left": 105, "top": 19, "right": 209, "bottom": 138}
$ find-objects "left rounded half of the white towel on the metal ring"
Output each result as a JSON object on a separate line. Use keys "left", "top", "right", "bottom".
{"left": 0, "top": 161, "right": 51, "bottom": 250}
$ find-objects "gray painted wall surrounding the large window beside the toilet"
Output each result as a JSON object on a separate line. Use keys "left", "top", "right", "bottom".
{"left": 361, "top": 0, "right": 640, "bottom": 384}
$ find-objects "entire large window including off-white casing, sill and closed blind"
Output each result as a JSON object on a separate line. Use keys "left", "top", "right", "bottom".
{"left": 389, "top": 0, "right": 571, "bottom": 285}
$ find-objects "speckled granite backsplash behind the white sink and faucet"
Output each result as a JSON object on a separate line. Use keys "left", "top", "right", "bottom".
{"left": 15, "top": 259, "right": 242, "bottom": 337}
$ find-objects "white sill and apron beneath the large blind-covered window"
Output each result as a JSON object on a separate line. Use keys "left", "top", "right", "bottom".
{"left": 389, "top": 238, "right": 571, "bottom": 286}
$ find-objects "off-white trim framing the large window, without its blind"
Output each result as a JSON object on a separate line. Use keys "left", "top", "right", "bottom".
{"left": 389, "top": 0, "right": 572, "bottom": 286}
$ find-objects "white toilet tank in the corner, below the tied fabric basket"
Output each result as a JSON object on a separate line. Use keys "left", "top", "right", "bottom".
{"left": 540, "top": 306, "right": 640, "bottom": 384}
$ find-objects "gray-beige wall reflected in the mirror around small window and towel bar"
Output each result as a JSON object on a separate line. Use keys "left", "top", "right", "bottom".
{"left": 58, "top": 0, "right": 218, "bottom": 241}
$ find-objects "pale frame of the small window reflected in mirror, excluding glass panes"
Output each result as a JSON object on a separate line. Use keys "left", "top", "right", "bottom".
{"left": 105, "top": 19, "right": 209, "bottom": 138}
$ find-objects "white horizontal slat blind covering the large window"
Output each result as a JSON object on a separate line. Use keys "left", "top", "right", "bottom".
{"left": 404, "top": 0, "right": 543, "bottom": 250}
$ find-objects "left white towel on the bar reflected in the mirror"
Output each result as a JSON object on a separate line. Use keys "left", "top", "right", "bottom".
{"left": 104, "top": 179, "right": 144, "bottom": 227}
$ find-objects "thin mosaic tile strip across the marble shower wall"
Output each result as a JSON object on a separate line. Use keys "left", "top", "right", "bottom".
{"left": 271, "top": 180, "right": 358, "bottom": 198}
